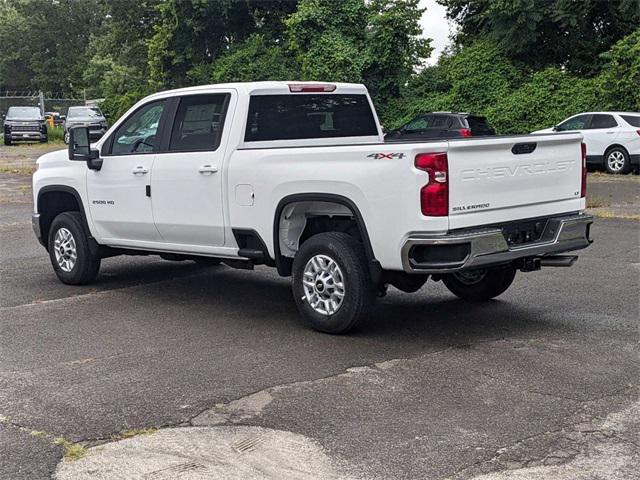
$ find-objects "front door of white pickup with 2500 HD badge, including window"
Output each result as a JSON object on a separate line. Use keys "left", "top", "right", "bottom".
{"left": 87, "top": 100, "right": 166, "bottom": 245}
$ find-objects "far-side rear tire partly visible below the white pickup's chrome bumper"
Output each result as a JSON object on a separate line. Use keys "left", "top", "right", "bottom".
{"left": 442, "top": 266, "right": 516, "bottom": 302}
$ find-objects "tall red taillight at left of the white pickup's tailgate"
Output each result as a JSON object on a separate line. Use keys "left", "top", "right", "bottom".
{"left": 415, "top": 153, "right": 449, "bottom": 217}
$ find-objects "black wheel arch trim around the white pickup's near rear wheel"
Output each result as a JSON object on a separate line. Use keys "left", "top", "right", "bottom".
{"left": 273, "top": 193, "right": 380, "bottom": 276}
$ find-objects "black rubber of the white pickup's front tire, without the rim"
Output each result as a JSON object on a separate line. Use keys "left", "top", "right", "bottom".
{"left": 48, "top": 212, "right": 100, "bottom": 285}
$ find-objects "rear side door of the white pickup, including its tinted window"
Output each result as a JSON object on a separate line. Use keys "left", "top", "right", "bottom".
{"left": 151, "top": 91, "right": 233, "bottom": 248}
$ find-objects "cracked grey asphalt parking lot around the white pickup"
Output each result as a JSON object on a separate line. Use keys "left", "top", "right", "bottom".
{"left": 0, "top": 147, "right": 640, "bottom": 480}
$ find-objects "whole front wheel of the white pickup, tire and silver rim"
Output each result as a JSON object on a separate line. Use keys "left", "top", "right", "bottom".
{"left": 49, "top": 212, "right": 100, "bottom": 285}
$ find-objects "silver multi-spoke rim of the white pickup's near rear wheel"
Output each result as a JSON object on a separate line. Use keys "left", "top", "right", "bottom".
{"left": 302, "top": 255, "right": 345, "bottom": 315}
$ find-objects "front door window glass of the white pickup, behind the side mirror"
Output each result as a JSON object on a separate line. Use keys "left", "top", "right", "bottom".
{"left": 110, "top": 100, "right": 166, "bottom": 155}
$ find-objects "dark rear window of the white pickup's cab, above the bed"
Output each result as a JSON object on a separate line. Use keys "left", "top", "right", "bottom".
{"left": 244, "top": 93, "right": 378, "bottom": 142}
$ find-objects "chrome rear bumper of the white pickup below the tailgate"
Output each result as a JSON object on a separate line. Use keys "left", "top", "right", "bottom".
{"left": 402, "top": 214, "right": 593, "bottom": 273}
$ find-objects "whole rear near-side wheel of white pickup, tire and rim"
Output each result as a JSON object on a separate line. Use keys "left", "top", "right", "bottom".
{"left": 292, "top": 232, "right": 375, "bottom": 334}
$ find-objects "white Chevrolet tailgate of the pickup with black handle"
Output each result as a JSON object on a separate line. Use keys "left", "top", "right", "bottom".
{"left": 448, "top": 134, "right": 584, "bottom": 229}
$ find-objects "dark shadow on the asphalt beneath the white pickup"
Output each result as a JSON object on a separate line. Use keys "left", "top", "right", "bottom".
{"left": 131, "top": 267, "right": 557, "bottom": 343}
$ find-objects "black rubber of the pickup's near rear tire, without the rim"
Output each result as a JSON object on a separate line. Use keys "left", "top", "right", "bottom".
{"left": 292, "top": 232, "right": 375, "bottom": 334}
